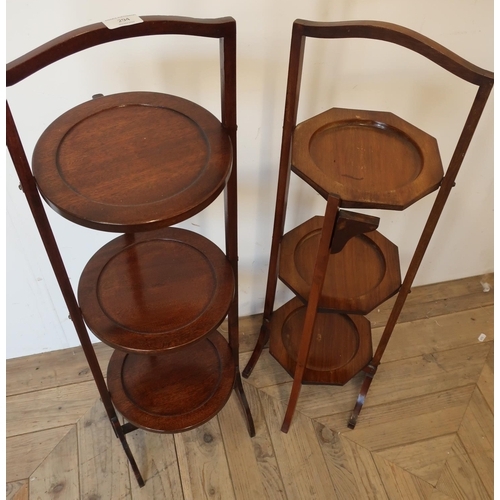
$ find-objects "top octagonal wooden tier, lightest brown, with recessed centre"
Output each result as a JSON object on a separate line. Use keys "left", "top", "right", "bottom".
{"left": 292, "top": 108, "right": 443, "bottom": 210}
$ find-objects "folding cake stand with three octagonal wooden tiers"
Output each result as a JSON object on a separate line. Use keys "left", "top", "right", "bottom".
{"left": 243, "top": 20, "right": 493, "bottom": 432}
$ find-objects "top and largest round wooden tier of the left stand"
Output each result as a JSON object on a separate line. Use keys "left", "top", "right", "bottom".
{"left": 33, "top": 92, "right": 232, "bottom": 233}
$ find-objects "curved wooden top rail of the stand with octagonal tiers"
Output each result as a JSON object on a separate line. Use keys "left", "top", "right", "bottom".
{"left": 293, "top": 19, "right": 493, "bottom": 85}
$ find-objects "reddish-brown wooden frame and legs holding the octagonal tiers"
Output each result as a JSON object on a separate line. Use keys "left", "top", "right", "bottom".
{"left": 243, "top": 19, "right": 493, "bottom": 432}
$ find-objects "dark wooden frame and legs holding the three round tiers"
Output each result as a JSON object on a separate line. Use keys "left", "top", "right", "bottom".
{"left": 6, "top": 16, "right": 255, "bottom": 486}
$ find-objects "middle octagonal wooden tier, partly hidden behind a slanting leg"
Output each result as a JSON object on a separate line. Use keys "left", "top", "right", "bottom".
{"left": 279, "top": 216, "right": 401, "bottom": 314}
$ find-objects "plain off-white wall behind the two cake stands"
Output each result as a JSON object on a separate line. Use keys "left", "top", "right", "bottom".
{"left": 6, "top": 0, "right": 493, "bottom": 358}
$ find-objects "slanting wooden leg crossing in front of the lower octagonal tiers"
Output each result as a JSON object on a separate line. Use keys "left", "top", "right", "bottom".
{"left": 281, "top": 195, "right": 340, "bottom": 433}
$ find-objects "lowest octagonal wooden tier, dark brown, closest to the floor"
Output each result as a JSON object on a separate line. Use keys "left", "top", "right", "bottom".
{"left": 269, "top": 298, "right": 372, "bottom": 385}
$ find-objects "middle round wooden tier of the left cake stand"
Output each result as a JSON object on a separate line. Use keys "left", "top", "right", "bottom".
{"left": 78, "top": 228, "right": 235, "bottom": 354}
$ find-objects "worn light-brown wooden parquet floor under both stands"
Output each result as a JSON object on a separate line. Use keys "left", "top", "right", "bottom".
{"left": 7, "top": 275, "right": 493, "bottom": 500}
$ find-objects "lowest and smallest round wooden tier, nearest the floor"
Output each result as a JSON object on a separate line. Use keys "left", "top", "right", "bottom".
{"left": 108, "top": 332, "right": 236, "bottom": 433}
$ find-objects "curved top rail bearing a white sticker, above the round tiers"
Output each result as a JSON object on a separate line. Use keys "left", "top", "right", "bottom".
{"left": 6, "top": 16, "right": 236, "bottom": 87}
